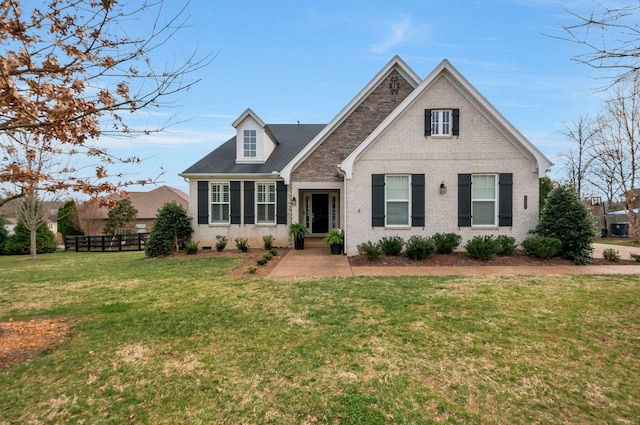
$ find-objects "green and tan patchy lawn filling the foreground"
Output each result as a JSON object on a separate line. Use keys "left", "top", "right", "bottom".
{"left": 0, "top": 253, "right": 640, "bottom": 424}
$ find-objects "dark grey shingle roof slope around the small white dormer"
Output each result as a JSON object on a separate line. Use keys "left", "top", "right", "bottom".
{"left": 183, "top": 124, "right": 326, "bottom": 174}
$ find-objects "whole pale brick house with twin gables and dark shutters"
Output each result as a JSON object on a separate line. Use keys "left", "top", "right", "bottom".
{"left": 181, "top": 56, "right": 550, "bottom": 255}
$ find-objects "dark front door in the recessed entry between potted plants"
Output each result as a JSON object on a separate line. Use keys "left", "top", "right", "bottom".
{"left": 301, "top": 190, "right": 340, "bottom": 235}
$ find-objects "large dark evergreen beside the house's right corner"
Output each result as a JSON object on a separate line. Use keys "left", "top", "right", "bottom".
{"left": 536, "top": 185, "right": 597, "bottom": 264}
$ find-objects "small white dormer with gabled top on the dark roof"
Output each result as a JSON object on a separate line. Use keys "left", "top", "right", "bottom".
{"left": 233, "top": 108, "right": 276, "bottom": 164}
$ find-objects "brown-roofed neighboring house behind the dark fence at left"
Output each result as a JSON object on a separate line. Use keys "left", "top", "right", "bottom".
{"left": 78, "top": 186, "right": 189, "bottom": 235}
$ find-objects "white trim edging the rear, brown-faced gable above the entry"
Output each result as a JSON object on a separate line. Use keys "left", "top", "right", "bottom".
{"left": 280, "top": 55, "right": 420, "bottom": 184}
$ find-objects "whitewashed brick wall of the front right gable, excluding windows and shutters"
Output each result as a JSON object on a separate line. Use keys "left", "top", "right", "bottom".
{"left": 346, "top": 78, "right": 539, "bottom": 255}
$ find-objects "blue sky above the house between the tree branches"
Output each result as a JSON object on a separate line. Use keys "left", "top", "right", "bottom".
{"left": 102, "top": 0, "right": 604, "bottom": 195}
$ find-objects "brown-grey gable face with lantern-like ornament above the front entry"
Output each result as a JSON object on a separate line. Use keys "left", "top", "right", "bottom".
{"left": 291, "top": 70, "right": 413, "bottom": 182}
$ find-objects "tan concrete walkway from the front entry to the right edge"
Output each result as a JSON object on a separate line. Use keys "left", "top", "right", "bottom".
{"left": 268, "top": 238, "right": 640, "bottom": 278}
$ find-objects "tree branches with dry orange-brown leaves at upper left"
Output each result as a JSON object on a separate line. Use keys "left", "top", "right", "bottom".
{"left": 0, "top": 0, "right": 207, "bottom": 206}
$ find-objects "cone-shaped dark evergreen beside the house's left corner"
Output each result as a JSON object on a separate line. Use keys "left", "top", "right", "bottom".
{"left": 145, "top": 201, "right": 193, "bottom": 257}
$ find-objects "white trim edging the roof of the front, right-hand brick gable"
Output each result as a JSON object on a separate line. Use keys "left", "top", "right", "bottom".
{"left": 339, "top": 59, "right": 551, "bottom": 178}
